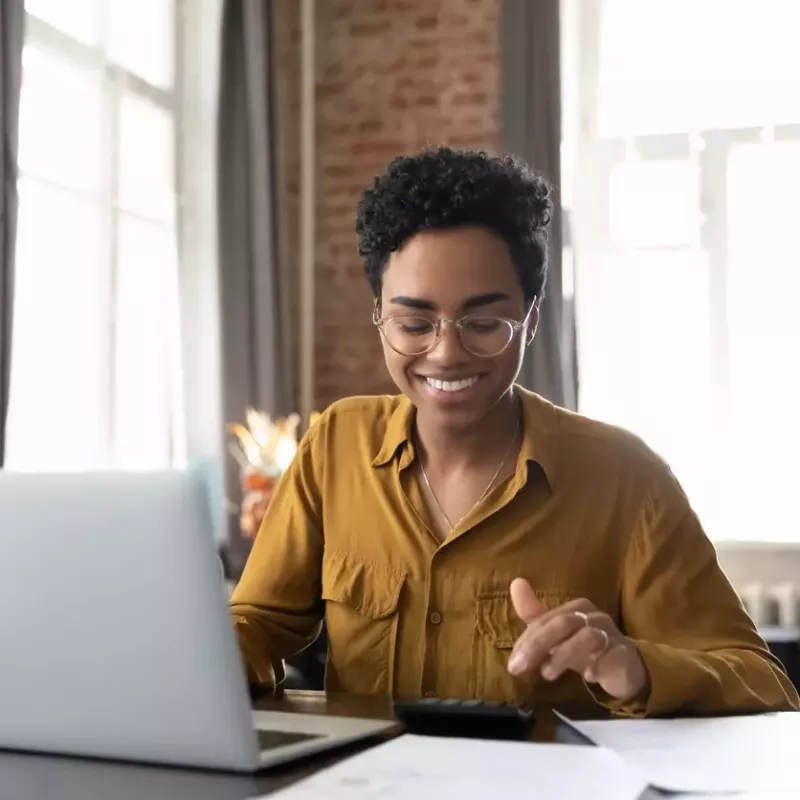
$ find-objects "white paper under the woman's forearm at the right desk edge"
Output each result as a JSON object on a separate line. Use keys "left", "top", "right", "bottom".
{"left": 561, "top": 711, "right": 800, "bottom": 797}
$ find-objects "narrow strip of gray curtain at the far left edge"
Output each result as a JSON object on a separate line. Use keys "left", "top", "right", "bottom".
{"left": 0, "top": 0, "right": 25, "bottom": 468}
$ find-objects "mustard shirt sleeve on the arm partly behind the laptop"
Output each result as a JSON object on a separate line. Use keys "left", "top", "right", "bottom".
{"left": 231, "top": 423, "right": 323, "bottom": 688}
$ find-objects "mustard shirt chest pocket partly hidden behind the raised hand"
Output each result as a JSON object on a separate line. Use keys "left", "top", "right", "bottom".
{"left": 473, "top": 591, "right": 581, "bottom": 703}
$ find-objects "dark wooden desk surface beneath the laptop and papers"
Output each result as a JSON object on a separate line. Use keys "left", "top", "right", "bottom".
{"left": 0, "top": 692, "right": 657, "bottom": 800}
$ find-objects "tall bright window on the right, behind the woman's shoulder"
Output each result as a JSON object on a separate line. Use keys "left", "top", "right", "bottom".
{"left": 565, "top": 0, "right": 800, "bottom": 541}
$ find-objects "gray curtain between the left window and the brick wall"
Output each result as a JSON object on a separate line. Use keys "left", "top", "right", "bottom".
{"left": 218, "top": 0, "right": 293, "bottom": 564}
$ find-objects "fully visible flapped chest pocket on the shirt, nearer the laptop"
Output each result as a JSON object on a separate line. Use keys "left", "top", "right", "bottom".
{"left": 322, "top": 553, "right": 405, "bottom": 694}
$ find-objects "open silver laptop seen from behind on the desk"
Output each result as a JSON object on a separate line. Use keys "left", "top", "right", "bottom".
{"left": 0, "top": 471, "right": 393, "bottom": 772}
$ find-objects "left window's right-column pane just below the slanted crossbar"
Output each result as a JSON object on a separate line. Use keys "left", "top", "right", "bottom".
{"left": 119, "top": 95, "right": 175, "bottom": 220}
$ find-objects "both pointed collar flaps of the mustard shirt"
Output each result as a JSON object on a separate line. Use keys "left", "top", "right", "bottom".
{"left": 372, "top": 386, "right": 560, "bottom": 489}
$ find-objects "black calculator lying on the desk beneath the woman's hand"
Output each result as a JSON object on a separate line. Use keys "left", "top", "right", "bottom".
{"left": 394, "top": 697, "right": 536, "bottom": 739}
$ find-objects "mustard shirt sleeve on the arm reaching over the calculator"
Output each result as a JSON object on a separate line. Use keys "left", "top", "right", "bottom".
{"left": 593, "top": 470, "right": 798, "bottom": 716}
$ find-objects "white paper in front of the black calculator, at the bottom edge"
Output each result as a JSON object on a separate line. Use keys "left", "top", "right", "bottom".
{"left": 262, "top": 735, "right": 647, "bottom": 800}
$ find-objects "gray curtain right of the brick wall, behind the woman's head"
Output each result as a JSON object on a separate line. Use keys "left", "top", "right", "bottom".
{"left": 500, "top": 0, "right": 578, "bottom": 409}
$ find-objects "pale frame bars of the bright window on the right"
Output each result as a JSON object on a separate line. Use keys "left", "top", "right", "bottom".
{"left": 562, "top": 0, "right": 800, "bottom": 545}
